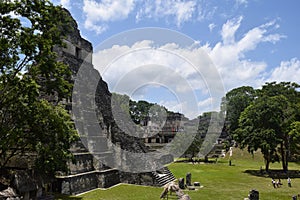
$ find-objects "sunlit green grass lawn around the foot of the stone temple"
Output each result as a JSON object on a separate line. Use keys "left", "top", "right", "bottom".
{"left": 58, "top": 149, "right": 300, "bottom": 200}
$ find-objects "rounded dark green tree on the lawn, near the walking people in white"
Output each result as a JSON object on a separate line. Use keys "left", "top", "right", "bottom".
{"left": 234, "top": 96, "right": 287, "bottom": 170}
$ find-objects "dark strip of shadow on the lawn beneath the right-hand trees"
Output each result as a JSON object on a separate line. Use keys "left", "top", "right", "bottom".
{"left": 244, "top": 170, "right": 300, "bottom": 179}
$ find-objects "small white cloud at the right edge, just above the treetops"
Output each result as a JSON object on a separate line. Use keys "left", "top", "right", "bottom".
{"left": 266, "top": 58, "right": 300, "bottom": 83}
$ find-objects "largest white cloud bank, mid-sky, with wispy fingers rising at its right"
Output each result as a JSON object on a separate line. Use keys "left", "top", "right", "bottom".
{"left": 94, "top": 17, "right": 288, "bottom": 117}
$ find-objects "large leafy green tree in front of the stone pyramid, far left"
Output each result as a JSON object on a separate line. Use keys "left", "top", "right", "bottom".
{"left": 0, "top": 0, "right": 77, "bottom": 175}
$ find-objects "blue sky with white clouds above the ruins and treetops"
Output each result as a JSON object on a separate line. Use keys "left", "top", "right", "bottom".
{"left": 52, "top": 0, "right": 300, "bottom": 118}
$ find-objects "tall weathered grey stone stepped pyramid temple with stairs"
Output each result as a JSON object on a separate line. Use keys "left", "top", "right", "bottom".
{"left": 54, "top": 10, "right": 175, "bottom": 194}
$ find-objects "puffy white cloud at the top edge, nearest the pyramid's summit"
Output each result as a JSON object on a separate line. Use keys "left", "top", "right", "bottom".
{"left": 83, "top": 0, "right": 135, "bottom": 34}
